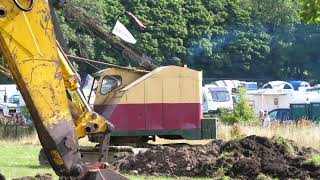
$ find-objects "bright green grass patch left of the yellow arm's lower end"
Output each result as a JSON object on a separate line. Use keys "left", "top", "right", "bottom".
{"left": 0, "top": 144, "right": 54, "bottom": 179}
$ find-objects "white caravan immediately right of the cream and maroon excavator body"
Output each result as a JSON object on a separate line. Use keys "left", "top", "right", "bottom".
{"left": 202, "top": 84, "right": 233, "bottom": 113}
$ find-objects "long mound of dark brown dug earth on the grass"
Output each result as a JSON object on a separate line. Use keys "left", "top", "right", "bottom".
{"left": 117, "top": 136, "right": 320, "bottom": 179}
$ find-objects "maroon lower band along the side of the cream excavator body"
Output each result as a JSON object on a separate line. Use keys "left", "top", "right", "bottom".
{"left": 94, "top": 103, "right": 201, "bottom": 130}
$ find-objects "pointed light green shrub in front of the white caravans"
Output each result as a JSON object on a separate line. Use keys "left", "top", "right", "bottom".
{"left": 220, "top": 88, "right": 261, "bottom": 124}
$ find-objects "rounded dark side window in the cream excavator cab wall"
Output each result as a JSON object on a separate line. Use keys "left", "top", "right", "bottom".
{"left": 100, "top": 75, "right": 122, "bottom": 95}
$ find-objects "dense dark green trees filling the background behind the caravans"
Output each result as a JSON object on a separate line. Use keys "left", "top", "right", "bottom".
{"left": 58, "top": 0, "right": 320, "bottom": 80}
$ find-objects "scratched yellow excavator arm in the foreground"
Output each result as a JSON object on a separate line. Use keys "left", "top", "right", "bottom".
{"left": 0, "top": 0, "right": 121, "bottom": 179}
